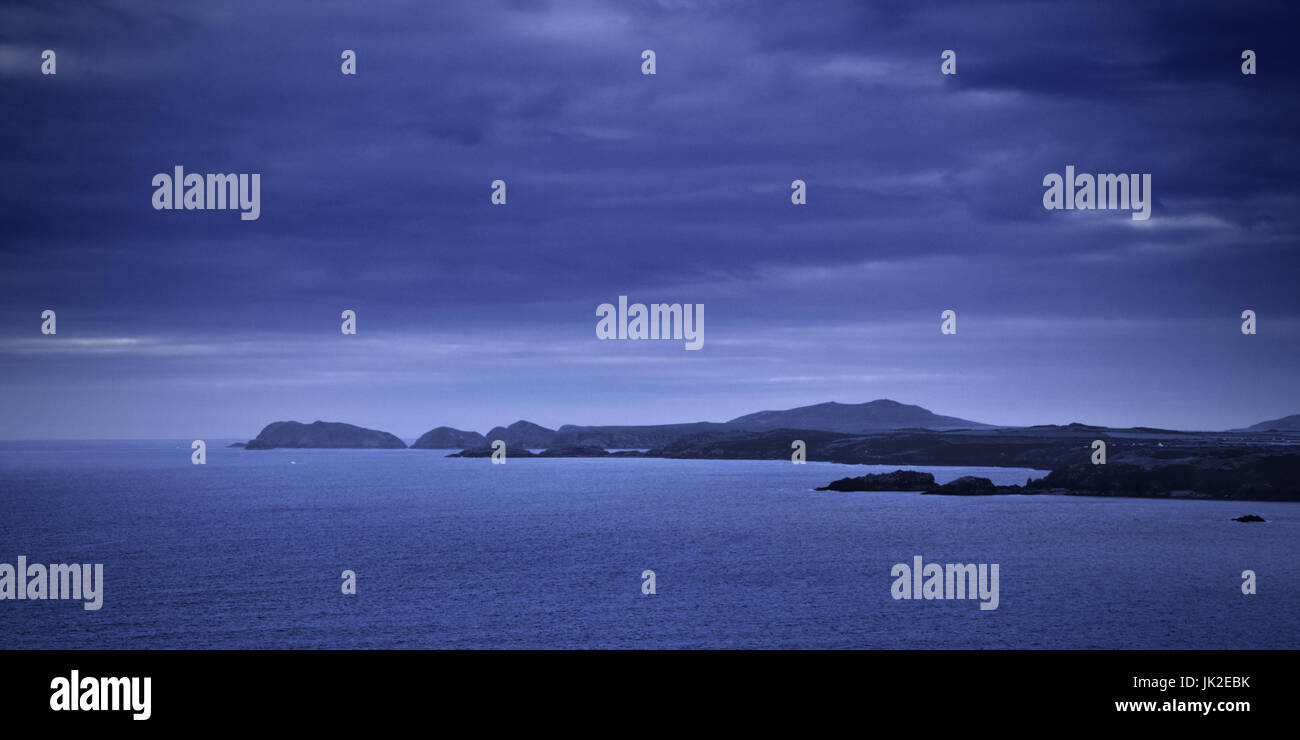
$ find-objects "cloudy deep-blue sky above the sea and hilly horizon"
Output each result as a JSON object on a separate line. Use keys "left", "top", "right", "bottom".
{"left": 0, "top": 0, "right": 1300, "bottom": 440}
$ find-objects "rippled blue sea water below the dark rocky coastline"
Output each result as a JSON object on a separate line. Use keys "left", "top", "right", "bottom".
{"left": 0, "top": 441, "right": 1300, "bottom": 649}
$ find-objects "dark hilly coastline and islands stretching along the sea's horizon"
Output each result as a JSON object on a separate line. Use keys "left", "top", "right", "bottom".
{"left": 246, "top": 399, "right": 1300, "bottom": 501}
